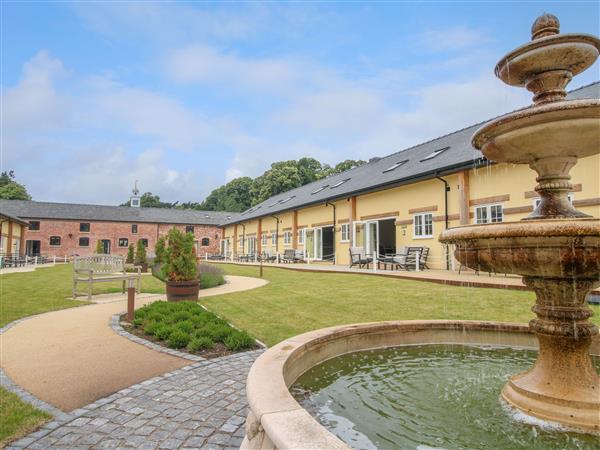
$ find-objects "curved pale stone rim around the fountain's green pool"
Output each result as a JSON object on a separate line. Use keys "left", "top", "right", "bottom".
{"left": 241, "top": 320, "right": 600, "bottom": 449}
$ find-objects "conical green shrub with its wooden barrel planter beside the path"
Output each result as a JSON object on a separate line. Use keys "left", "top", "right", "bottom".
{"left": 162, "top": 228, "right": 200, "bottom": 302}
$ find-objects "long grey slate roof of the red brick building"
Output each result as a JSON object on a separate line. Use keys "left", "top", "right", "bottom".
{"left": 0, "top": 200, "right": 239, "bottom": 225}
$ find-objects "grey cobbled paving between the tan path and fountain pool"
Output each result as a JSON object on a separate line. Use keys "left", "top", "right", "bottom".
{"left": 14, "top": 351, "right": 260, "bottom": 450}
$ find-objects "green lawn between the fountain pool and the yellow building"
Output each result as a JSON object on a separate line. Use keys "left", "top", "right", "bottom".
{"left": 201, "top": 264, "right": 600, "bottom": 346}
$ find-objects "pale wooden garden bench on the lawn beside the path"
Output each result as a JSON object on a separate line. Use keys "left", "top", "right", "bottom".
{"left": 73, "top": 255, "right": 142, "bottom": 300}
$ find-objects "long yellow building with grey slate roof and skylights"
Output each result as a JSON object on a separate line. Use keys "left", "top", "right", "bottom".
{"left": 221, "top": 82, "right": 600, "bottom": 269}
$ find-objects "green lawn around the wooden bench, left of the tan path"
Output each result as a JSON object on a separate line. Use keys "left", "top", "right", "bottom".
{"left": 0, "top": 264, "right": 165, "bottom": 327}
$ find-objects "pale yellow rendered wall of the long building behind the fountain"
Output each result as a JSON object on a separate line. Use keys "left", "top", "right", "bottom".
{"left": 224, "top": 155, "right": 600, "bottom": 269}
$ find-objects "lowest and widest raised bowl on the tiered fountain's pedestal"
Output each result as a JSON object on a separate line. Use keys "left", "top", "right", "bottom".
{"left": 440, "top": 219, "right": 600, "bottom": 278}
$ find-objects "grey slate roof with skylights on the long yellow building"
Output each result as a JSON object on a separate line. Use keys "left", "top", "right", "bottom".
{"left": 225, "top": 81, "right": 600, "bottom": 224}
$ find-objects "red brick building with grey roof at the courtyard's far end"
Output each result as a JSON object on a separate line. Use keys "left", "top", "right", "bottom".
{"left": 0, "top": 197, "right": 238, "bottom": 257}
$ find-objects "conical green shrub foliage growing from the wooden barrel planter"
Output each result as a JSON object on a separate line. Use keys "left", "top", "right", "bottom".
{"left": 162, "top": 228, "right": 198, "bottom": 281}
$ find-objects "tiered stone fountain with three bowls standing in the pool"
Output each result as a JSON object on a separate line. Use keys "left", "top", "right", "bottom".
{"left": 440, "top": 14, "right": 600, "bottom": 431}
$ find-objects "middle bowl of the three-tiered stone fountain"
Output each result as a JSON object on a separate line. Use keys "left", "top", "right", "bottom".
{"left": 473, "top": 99, "right": 600, "bottom": 164}
